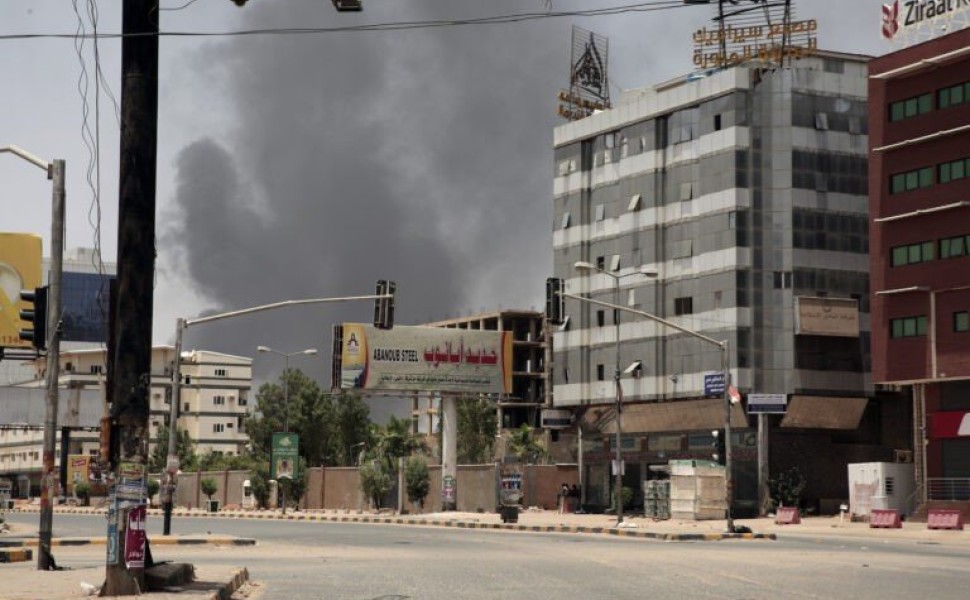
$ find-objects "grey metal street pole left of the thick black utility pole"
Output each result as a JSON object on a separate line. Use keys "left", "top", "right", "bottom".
{"left": 37, "top": 159, "right": 66, "bottom": 571}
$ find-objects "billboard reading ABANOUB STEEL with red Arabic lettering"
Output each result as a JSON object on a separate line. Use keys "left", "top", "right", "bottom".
{"left": 334, "top": 323, "right": 512, "bottom": 394}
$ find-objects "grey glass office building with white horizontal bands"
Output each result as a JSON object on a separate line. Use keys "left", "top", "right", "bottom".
{"left": 553, "top": 52, "right": 909, "bottom": 510}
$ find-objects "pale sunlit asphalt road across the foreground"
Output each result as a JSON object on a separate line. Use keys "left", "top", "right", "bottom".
{"left": 10, "top": 515, "right": 970, "bottom": 600}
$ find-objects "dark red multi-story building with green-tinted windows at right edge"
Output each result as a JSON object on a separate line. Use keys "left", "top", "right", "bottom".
{"left": 869, "top": 29, "right": 970, "bottom": 511}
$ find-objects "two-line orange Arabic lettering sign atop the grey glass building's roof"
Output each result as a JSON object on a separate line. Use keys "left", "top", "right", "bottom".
{"left": 693, "top": 0, "right": 818, "bottom": 70}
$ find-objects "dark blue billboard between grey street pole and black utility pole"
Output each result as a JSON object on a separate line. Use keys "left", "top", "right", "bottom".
{"left": 61, "top": 271, "right": 112, "bottom": 343}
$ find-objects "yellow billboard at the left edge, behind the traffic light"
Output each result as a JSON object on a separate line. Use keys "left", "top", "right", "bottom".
{"left": 0, "top": 233, "right": 43, "bottom": 348}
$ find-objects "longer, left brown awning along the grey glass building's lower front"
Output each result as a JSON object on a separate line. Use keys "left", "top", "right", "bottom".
{"left": 580, "top": 398, "right": 748, "bottom": 434}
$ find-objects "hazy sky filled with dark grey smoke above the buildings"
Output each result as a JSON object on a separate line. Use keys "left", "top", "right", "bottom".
{"left": 0, "top": 0, "right": 893, "bottom": 382}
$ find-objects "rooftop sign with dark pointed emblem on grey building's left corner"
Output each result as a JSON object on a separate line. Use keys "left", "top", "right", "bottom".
{"left": 558, "top": 25, "right": 610, "bottom": 121}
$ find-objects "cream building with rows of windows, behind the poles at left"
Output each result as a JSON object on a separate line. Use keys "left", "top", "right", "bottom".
{"left": 0, "top": 346, "right": 252, "bottom": 496}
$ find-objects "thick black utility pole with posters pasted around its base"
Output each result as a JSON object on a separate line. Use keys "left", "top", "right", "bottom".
{"left": 103, "top": 0, "right": 158, "bottom": 596}
